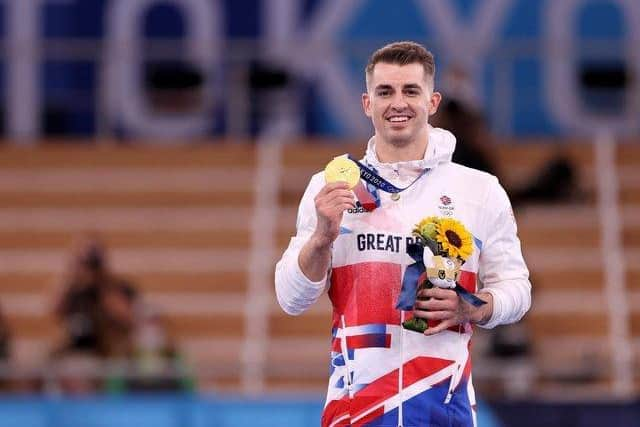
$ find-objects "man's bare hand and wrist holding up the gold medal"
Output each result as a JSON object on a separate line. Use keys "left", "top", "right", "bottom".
{"left": 312, "top": 182, "right": 356, "bottom": 247}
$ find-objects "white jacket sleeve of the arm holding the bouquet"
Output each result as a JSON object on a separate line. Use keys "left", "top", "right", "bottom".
{"left": 478, "top": 177, "right": 531, "bottom": 329}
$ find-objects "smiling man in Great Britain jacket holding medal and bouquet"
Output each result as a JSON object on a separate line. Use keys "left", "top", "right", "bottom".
{"left": 275, "top": 42, "right": 531, "bottom": 427}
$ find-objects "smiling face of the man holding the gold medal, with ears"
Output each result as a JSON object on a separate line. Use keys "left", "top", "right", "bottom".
{"left": 362, "top": 62, "right": 441, "bottom": 146}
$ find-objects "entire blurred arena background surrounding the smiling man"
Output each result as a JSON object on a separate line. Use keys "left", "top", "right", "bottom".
{"left": 0, "top": 0, "right": 640, "bottom": 426}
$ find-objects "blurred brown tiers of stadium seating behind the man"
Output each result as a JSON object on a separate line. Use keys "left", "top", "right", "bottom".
{"left": 0, "top": 141, "right": 640, "bottom": 394}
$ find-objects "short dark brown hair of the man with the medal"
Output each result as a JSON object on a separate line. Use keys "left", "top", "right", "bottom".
{"left": 365, "top": 41, "right": 436, "bottom": 87}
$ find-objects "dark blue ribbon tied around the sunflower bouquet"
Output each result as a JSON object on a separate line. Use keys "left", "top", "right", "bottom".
{"left": 396, "top": 243, "right": 486, "bottom": 311}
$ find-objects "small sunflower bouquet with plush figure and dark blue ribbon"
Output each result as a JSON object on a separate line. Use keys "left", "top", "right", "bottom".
{"left": 397, "top": 216, "right": 482, "bottom": 332}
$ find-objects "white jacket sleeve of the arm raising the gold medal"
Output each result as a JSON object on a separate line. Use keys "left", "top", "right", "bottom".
{"left": 275, "top": 176, "right": 328, "bottom": 315}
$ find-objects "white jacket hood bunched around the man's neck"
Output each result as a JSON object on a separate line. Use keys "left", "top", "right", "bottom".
{"left": 364, "top": 126, "right": 456, "bottom": 170}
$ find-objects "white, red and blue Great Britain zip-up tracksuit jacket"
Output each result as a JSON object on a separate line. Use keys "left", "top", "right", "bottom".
{"left": 275, "top": 128, "right": 531, "bottom": 427}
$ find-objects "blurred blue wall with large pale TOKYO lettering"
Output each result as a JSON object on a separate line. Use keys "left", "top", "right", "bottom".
{"left": 0, "top": 0, "right": 640, "bottom": 139}
